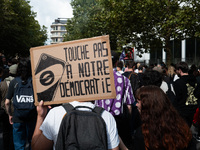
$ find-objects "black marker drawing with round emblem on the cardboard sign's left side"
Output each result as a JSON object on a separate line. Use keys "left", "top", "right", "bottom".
{"left": 35, "top": 53, "right": 65, "bottom": 102}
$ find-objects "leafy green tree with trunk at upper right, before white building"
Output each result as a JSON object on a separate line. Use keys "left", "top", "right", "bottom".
{"left": 131, "top": 0, "right": 198, "bottom": 65}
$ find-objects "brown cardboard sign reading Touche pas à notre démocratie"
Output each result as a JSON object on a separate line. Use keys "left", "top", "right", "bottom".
{"left": 30, "top": 35, "right": 116, "bottom": 105}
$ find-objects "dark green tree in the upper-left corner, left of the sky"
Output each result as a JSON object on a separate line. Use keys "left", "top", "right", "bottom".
{"left": 0, "top": 0, "right": 47, "bottom": 56}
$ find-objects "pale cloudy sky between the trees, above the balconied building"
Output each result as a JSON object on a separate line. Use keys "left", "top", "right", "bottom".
{"left": 30, "top": 0, "right": 73, "bottom": 44}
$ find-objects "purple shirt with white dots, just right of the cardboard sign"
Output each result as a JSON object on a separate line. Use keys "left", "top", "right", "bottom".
{"left": 95, "top": 70, "right": 135, "bottom": 116}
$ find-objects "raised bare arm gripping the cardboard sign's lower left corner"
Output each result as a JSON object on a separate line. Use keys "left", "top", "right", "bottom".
{"left": 31, "top": 101, "right": 53, "bottom": 150}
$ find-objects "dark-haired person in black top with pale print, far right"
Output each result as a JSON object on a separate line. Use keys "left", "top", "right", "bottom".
{"left": 174, "top": 62, "right": 200, "bottom": 127}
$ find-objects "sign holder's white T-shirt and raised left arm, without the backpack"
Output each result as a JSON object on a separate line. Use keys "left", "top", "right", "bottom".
{"left": 32, "top": 101, "right": 120, "bottom": 150}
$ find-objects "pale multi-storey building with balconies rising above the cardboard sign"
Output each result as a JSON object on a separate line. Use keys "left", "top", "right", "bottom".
{"left": 51, "top": 18, "right": 68, "bottom": 44}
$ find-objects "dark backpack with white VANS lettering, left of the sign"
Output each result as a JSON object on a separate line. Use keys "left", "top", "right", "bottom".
{"left": 13, "top": 77, "right": 36, "bottom": 120}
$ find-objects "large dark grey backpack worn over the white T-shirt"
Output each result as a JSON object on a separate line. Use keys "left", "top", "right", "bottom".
{"left": 55, "top": 104, "right": 108, "bottom": 150}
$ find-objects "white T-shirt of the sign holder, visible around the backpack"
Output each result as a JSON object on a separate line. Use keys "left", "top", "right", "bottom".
{"left": 40, "top": 101, "right": 119, "bottom": 150}
